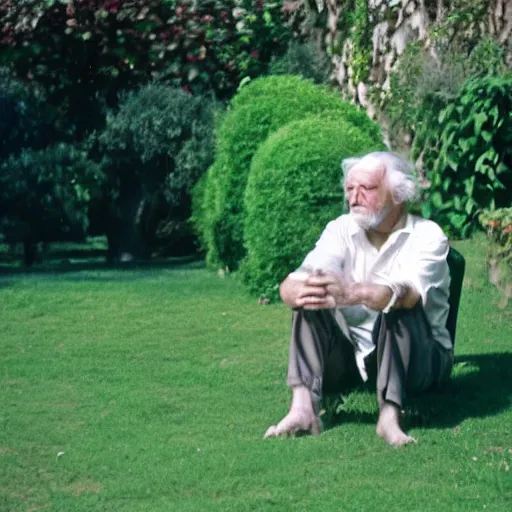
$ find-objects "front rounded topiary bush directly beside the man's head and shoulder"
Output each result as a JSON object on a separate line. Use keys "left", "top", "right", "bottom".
{"left": 241, "top": 116, "right": 384, "bottom": 299}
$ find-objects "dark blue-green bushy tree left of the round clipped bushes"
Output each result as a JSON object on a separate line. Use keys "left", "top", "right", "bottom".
{"left": 98, "top": 84, "right": 214, "bottom": 257}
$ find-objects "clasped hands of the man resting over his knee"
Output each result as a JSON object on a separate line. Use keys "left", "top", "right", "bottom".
{"left": 296, "top": 271, "right": 354, "bottom": 309}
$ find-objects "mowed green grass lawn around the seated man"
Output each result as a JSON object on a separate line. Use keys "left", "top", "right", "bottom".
{"left": 0, "top": 241, "right": 512, "bottom": 512}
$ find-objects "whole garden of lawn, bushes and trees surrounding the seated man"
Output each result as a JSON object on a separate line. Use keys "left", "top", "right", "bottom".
{"left": 0, "top": 0, "right": 512, "bottom": 511}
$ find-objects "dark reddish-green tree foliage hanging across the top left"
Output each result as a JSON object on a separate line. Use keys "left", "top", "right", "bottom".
{"left": 0, "top": 0, "right": 290, "bottom": 138}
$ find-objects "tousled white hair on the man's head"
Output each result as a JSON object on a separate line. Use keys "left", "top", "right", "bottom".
{"left": 341, "top": 151, "right": 419, "bottom": 204}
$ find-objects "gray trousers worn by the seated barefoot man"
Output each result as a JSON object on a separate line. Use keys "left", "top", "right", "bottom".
{"left": 287, "top": 303, "right": 453, "bottom": 407}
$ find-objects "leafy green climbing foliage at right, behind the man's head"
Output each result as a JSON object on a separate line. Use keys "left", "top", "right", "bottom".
{"left": 384, "top": 38, "right": 510, "bottom": 237}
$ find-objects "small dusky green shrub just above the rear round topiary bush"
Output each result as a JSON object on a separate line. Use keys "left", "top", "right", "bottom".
{"left": 269, "top": 41, "right": 331, "bottom": 84}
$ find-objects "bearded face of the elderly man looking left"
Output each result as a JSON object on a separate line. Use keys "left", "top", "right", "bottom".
{"left": 345, "top": 159, "right": 393, "bottom": 229}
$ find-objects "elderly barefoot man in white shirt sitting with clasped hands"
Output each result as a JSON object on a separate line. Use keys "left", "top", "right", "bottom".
{"left": 265, "top": 152, "right": 453, "bottom": 446}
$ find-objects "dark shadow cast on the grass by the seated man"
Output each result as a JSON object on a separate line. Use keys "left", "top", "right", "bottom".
{"left": 326, "top": 352, "right": 512, "bottom": 429}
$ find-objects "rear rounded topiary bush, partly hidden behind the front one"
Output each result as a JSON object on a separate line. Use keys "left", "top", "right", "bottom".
{"left": 207, "top": 75, "right": 381, "bottom": 269}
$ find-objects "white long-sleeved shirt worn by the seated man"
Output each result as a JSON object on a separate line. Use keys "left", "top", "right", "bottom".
{"left": 290, "top": 214, "right": 452, "bottom": 380}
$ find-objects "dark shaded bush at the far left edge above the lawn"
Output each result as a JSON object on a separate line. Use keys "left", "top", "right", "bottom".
{"left": 0, "top": 144, "right": 102, "bottom": 263}
